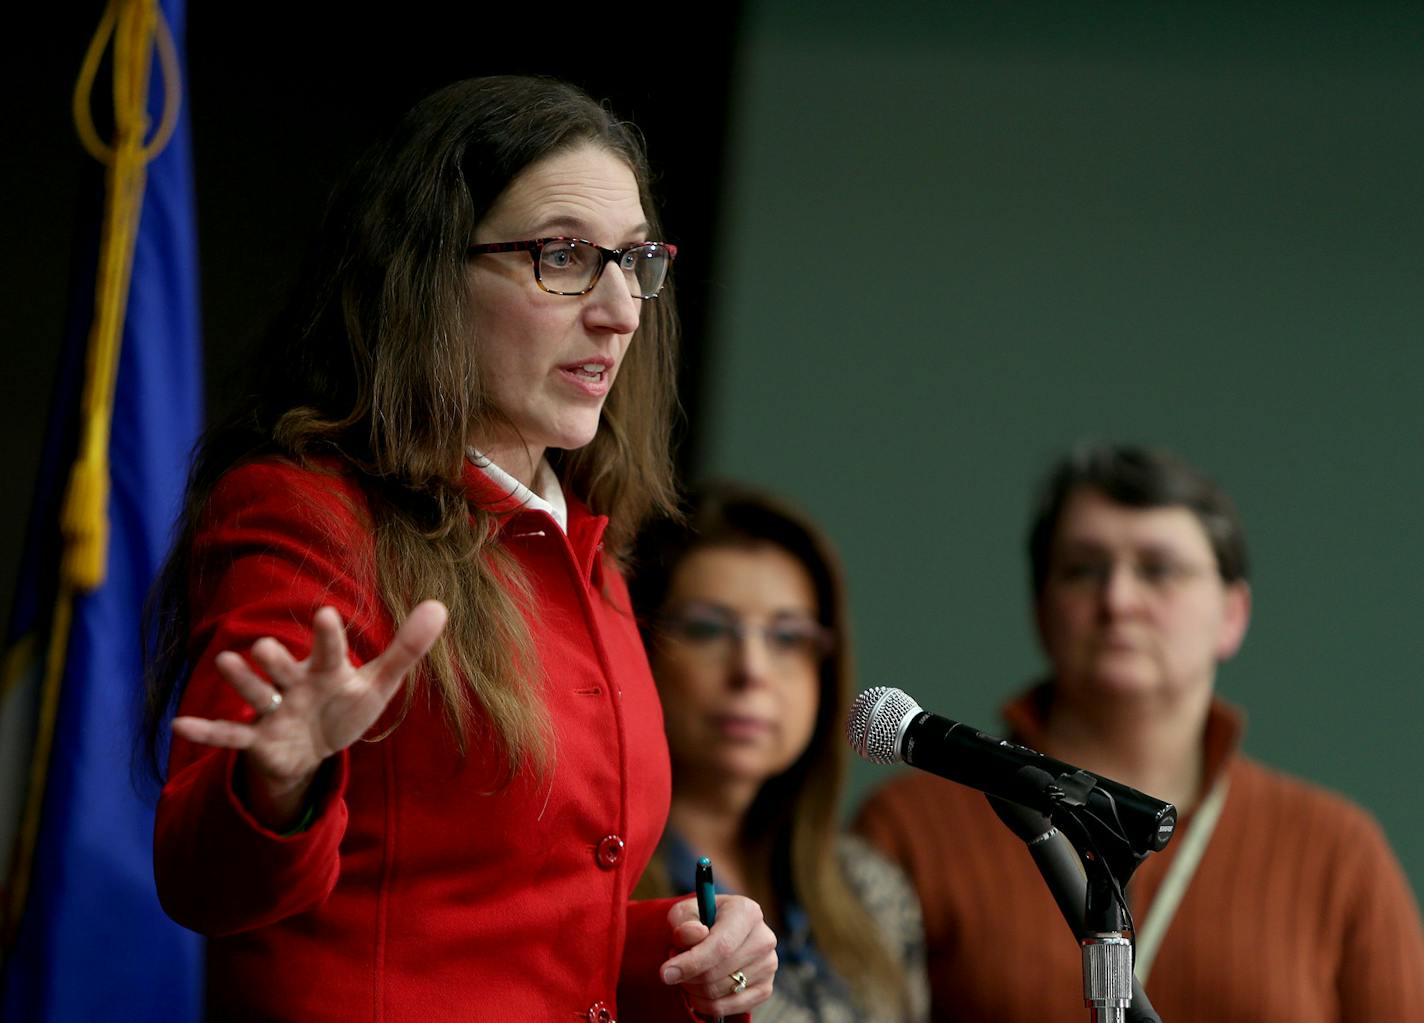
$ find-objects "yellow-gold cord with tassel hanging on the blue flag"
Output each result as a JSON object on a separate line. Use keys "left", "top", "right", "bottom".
{"left": 4, "top": 0, "right": 182, "bottom": 947}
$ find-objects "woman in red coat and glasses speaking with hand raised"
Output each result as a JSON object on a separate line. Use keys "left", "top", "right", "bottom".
{"left": 138, "top": 78, "right": 776, "bottom": 1023}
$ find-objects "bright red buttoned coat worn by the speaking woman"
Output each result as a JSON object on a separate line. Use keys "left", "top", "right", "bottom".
{"left": 155, "top": 460, "right": 686, "bottom": 1023}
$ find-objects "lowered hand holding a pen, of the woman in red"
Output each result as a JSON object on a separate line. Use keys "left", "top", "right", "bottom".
{"left": 661, "top": 895, "right": 776, "bottom": 1017}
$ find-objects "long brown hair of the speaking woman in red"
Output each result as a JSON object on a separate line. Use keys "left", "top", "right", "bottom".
{"left": 145, "top": 77, "right": 678, "bottom": 777}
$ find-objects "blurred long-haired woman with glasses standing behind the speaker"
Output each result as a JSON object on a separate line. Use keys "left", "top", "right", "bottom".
{"left": 629, "top": 484, "right": 928, "bottom": 1023}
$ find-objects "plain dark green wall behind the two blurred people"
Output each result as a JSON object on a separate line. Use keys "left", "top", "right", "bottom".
{"left": 698, "top": 3, "right": 1424, "bottom": 890}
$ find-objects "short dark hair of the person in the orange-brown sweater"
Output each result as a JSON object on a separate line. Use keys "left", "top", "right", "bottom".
{"left": 1028, "top": 443, "right": 1249, "bottom": 596}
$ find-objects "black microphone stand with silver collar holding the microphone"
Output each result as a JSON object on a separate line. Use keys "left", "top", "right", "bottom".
{"left": 988, "top": 769, "right": 1175, "bottom": 1023}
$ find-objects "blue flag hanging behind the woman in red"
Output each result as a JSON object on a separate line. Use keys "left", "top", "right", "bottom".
{"left": 0, "top": 0, "right": 202, "bottom": 1023}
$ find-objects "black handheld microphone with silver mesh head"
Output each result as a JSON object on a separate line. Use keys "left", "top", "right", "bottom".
{"left": 846, "top": 685, "right": 1176, "bottom": 859}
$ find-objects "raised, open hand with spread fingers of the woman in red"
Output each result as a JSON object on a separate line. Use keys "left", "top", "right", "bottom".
{"left": 174, "top": 600, "right": 447, "bottom": 829}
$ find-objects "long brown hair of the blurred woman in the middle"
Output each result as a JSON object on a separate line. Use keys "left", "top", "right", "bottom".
{"left": 629, "top": 482, "right": 906, "bottom": 1010}
